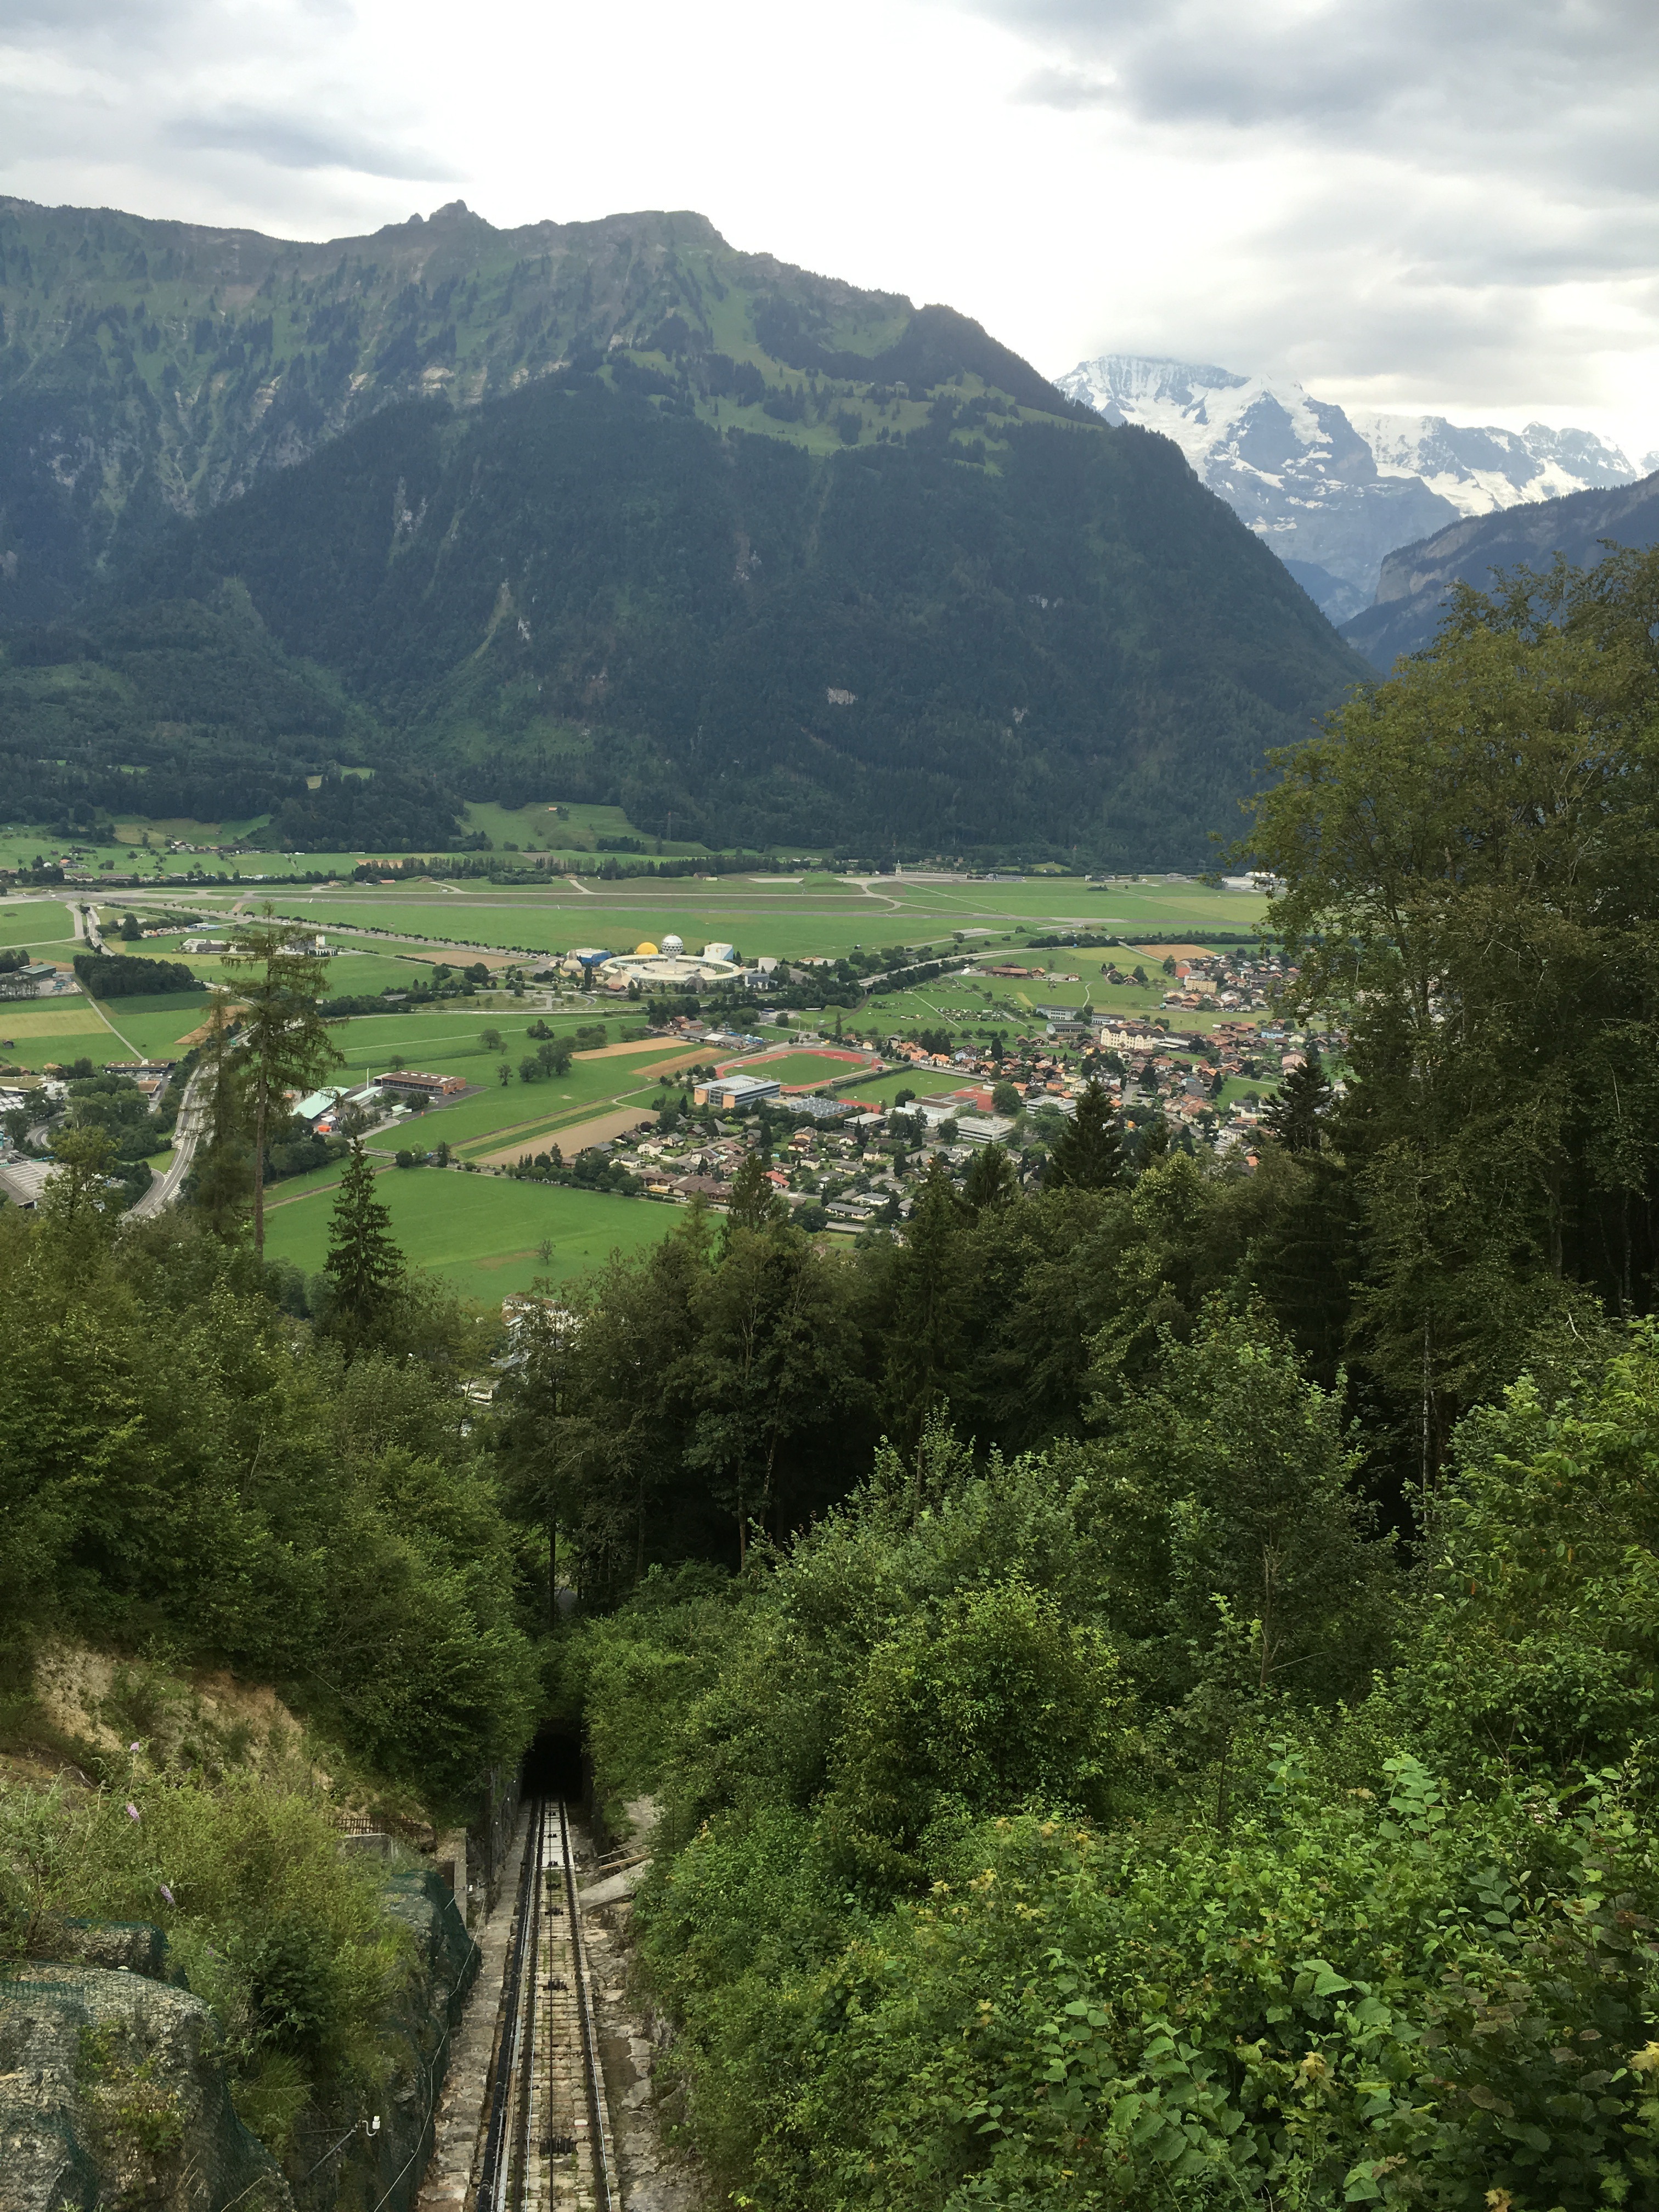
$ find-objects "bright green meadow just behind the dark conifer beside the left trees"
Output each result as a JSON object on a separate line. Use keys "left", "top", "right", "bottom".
{"left": 266, "top": 1168, "right": 681, "bottom": 1305}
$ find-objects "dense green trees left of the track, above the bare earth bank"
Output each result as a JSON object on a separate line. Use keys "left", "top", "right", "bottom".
{"left": 0, "top": 1212, "right": 535, "bottom": 1805}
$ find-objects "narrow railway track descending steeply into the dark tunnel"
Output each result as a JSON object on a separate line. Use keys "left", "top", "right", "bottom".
{"left": 471, "top": 1798, "right": 624, "bottom": 2212}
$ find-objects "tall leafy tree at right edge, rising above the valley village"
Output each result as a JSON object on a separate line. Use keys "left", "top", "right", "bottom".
{"left": 1252, "top": 551, "right": 1659, "bottom": 1493}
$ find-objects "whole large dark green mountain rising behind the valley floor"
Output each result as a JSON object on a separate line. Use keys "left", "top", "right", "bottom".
{"left": 0, "top": 199, "right": 1380, "bottom": 867}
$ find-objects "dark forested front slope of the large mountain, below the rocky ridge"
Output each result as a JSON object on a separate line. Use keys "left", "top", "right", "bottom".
{"left": 144, "top": 369, "right": 1350, "bottom": 860}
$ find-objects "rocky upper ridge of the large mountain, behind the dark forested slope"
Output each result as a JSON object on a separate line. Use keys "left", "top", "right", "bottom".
{"left": 0, "top": 197, "right": 1092, "bottom": 622}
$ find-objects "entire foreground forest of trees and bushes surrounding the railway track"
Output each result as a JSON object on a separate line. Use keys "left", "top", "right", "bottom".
{"left": 0, "top": 553, "right": 1659, "bottom": 2212}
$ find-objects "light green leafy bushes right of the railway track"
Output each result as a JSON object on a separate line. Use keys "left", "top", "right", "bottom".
{"left": 577, "top": 1310, "right": 1659, "bottom": 2212}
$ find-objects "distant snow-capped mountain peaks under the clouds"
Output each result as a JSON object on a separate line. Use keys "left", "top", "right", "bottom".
{"left": 1057, "top": 354, "right": 1659, "bottom": 624}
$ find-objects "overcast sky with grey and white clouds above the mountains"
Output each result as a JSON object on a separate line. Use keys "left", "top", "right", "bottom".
{"left": 0, "top": 0, "right": 1659, "bottom": 460}
